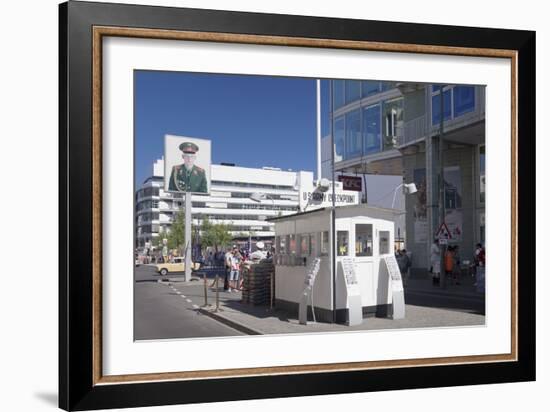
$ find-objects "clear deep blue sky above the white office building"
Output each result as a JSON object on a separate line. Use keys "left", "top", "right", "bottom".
{"left": 135, "top": 71, "right": 329, "bottom": 186}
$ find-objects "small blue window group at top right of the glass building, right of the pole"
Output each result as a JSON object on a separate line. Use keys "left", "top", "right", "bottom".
{"left": 432, "top": 86, "right": 475, "bottom": 125}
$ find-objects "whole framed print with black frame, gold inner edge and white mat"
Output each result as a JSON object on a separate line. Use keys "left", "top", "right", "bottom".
{"left": 59, "top": 1, "right": 535, "bottom": 410}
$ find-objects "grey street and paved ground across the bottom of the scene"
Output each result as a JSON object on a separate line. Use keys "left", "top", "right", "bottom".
{"left": 134, "top": 265, "right": 485, "bottom": 340}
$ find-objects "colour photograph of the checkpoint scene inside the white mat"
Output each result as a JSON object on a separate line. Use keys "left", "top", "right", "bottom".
{"left": 133, "top": 70, "right": 491, "bottom": 340}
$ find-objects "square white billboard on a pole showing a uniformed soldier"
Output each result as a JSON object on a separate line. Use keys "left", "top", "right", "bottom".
{"left": 164, "top": 135, "right": 211, "bottom": 194}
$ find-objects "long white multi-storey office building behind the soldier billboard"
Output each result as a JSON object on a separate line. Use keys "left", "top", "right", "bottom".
{"left": 135, "top": 159, "right": 359, "bottom": 247}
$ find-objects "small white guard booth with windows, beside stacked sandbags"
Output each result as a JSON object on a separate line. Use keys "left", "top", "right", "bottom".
{"left": 270, "top": 204, "right": 404, "bottom": 325}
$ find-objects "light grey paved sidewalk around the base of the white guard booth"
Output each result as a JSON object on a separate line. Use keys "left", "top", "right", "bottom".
{"left": 168, "top": 279, "right": 485, "bottom": 335}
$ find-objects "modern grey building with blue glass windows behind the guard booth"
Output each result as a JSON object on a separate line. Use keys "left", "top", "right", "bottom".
{"left": 323, "top": 80, "right": 486, "bottom": 271}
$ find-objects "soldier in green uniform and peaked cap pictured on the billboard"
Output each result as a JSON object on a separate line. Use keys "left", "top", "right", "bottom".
{"left": 168, "top": 142, "right": 208, "bottom": 193}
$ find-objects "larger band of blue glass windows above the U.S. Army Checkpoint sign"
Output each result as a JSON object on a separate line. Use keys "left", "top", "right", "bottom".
{"left": 334, "top": 98, "right": 403, "bottom": 161}
